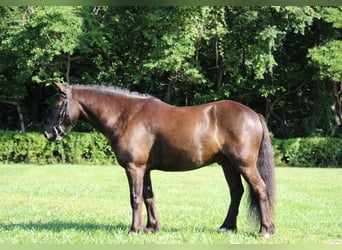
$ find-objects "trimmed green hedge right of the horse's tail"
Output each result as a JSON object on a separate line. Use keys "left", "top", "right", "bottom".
{"left": 273, "top": 138, "right": 342, "bottom": 167}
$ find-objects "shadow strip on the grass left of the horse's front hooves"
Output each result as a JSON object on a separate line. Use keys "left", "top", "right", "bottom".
{"left": 0, "top": 221, "right": 130, "bottom": 232}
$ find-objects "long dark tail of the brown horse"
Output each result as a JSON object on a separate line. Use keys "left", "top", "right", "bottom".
{"left": 249, "top": 114, "right": 275, "bottom": 219}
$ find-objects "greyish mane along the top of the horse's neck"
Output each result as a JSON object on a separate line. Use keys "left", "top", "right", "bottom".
{"left": 70, "top": 84, "right": 156, "bottom": 99}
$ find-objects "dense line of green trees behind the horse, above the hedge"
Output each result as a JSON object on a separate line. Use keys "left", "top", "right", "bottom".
{"left": 0, "top": 6, "right": 342, "bottom": 137}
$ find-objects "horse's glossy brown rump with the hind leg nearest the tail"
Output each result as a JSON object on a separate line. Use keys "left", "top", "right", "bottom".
{"left": 216, "top": 104, "right": 275, "bottom": 236}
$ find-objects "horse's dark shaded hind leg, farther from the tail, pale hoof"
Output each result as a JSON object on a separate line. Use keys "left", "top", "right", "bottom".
{"left": 219, "top": 160, "right": 244, "bottom": 233}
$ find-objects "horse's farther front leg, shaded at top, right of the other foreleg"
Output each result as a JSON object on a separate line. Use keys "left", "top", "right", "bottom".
{"left": 143, "top": 171, "right": 161, "bottom": 232}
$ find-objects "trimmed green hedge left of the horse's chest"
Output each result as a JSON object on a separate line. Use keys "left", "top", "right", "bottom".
{"left": 0, "top": 131, "right": 116, "bottom": 164}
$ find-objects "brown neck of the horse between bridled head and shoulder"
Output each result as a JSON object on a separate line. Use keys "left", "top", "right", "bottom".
{"left": 73, "top": 89, "right": 129, "bottom": 137}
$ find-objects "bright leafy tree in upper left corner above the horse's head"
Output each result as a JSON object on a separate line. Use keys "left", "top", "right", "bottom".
{"left": 0, "top": 6, "right": 111, "bottom": 129}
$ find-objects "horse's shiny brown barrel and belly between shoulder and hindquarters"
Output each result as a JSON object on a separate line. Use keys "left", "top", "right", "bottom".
{"left": 151, "top": 105, "right": 220, "bottom": 171}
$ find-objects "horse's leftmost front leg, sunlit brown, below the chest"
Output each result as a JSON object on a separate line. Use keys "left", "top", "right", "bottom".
{"left": 126, "top": 163, "right": 147, "bottom": 234}
